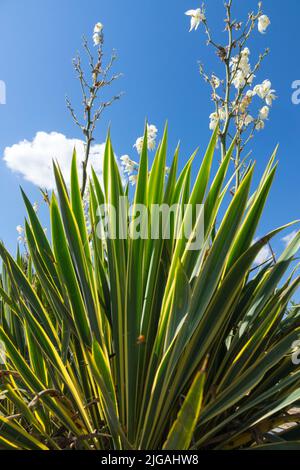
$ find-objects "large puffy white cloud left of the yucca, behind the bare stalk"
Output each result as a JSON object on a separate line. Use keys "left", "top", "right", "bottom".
{"left": 4, "top": 131, "right": 105, "bottom": 189}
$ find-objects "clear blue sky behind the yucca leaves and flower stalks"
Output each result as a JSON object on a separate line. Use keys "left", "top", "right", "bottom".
{"left": 0, "top": 0, "right": 300, "bottom": 260}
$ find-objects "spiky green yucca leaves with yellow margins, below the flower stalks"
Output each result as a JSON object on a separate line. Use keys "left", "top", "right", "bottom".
{"left": 0, "top": 123, "right": 300, "bottom": 450}
